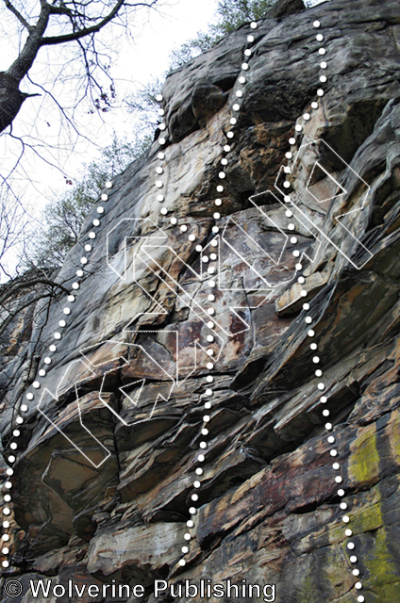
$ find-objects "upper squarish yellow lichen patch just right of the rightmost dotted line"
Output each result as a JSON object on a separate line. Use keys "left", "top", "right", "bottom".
{"left": 349, "top": 425, "right": 379, "bottom": 487}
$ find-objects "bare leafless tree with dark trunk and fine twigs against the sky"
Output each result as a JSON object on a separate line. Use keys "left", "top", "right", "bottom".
{"left": 0, "top": 0, "right": 165, "bottom": 281}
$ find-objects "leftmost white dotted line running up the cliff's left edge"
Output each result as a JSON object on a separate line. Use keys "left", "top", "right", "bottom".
{"left": 1, "top": 182, "right": 112, "bottom": 568}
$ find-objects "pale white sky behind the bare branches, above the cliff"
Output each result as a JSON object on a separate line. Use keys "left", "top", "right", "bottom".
{"left": 0, "top": 0, "right": 217, "bottom": 278}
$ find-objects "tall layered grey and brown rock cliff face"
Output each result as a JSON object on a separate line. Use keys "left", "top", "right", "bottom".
{"left": 1, "top": 0, "right": 400, "bottom": 603}
